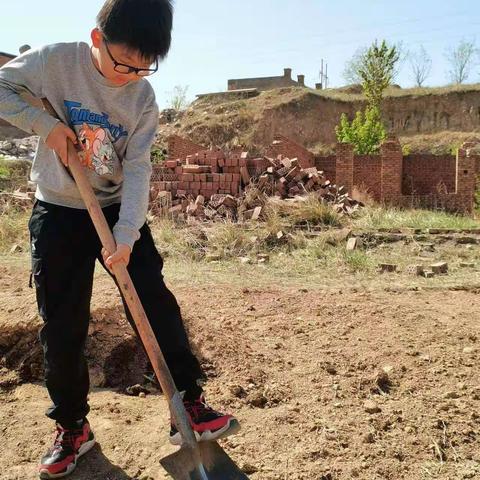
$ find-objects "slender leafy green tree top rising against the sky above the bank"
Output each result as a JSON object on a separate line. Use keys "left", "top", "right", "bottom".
{"left": 358, "top": 40, "right": 400, "bottom": 109}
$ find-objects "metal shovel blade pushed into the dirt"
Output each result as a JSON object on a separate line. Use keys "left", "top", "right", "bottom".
{"left": 160, "top": 441, "right": 248, "bottom": 480}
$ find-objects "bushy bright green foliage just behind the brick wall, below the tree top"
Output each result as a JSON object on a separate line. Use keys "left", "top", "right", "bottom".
{"left": 335, "top": 106, "right": 387, "bottom": 155}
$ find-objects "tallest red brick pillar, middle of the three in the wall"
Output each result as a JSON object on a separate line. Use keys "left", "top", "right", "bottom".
{"left": 380, "top": 137, "right": 403, "bottom": 202}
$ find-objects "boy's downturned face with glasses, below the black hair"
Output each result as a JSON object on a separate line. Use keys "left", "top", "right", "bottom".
{"left": 91, "top": 28, "right": 155, "bottom": 86}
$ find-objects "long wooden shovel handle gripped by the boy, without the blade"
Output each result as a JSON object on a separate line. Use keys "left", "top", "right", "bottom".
{"left": 42, "top": 99, "right": 196, "bottom": 447}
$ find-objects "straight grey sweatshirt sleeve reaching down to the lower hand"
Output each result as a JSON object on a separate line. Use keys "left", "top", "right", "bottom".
{"left": 113, "top": 98, "right": 159, "bottom": 248}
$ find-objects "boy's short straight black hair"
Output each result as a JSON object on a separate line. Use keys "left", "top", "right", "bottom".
{"left": 97, "top": 0, "right": 173, "bottom": 59}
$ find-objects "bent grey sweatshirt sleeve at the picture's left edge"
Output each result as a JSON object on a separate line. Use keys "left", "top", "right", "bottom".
{"left": 0, "top": 49, "right": 58, "bottom": 140}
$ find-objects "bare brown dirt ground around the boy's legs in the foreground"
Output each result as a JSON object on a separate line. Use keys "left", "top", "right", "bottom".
{"left": 0, "top": 255, "right": 480, "bottom": 480}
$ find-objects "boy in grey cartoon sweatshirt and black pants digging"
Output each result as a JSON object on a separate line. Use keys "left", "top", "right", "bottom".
{"left": 0, "top": 0, "right": 239, "bottom": 478}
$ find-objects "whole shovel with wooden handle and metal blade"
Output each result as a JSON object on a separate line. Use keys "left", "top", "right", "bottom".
{"left": 42, "top": 99, "right": 248, "bottom": 480}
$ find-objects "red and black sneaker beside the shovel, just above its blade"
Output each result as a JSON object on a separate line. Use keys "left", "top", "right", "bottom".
{"left": 170, "top": 394, "right": 240, "bottom": 445}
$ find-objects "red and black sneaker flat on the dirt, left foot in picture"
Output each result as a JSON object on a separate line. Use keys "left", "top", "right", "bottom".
{"left": 38, "top": 419, "right": 95, "bottom": 479}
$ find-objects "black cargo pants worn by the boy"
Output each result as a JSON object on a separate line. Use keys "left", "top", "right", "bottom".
{"left": 29, "top": 200, "right": 203, "bottom": 427}
